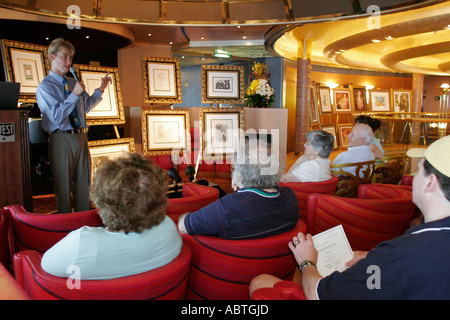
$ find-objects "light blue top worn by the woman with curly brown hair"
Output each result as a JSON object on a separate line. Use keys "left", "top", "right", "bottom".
{"left": 41, "top": 216, "right": 183, "bottom": 280}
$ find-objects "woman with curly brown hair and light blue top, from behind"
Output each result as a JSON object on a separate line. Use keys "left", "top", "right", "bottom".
{"left": 41, "top": 154, "right": 183, "bottom": 280}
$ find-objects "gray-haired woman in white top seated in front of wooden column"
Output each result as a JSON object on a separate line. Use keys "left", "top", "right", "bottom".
{"left": 280, "top": 130, "right": 334, "bottom": 182}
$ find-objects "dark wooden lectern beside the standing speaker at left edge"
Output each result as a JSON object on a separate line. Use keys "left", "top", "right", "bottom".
{"left": 0, "top": 109, "right": 33, "bottom": 212}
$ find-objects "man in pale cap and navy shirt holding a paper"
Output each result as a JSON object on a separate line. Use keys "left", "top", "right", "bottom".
{"left": 250, "top": 136, "right": 450, "bottom": 300}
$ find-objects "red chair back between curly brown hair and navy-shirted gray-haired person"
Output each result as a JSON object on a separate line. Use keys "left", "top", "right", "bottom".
{"left": 166, "top": 183, "right": 219, "bottom": 223}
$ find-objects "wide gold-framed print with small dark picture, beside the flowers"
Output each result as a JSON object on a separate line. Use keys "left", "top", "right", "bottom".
{"left": 202, "top": 65, "right": 244, "bottom": 103}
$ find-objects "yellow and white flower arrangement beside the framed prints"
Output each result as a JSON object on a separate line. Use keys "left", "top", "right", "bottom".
{"left": 244, "top": 62, "right": 275, "bottom": 108}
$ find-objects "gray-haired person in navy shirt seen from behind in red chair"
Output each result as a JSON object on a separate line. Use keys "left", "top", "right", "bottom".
{"left": 178, "top": 141, "right": 300, "bottom": 239}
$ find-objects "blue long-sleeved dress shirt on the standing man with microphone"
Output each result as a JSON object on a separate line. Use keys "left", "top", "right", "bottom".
{"left": 36, "top": 71, "right": 102, "bottom": 132}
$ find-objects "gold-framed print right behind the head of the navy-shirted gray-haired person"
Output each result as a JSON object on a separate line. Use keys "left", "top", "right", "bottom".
{"left": 200, "top": 108, "right": 244, "bottom": 159}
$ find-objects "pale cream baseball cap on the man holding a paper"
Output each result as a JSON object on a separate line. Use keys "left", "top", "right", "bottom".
{"left": 406, "top": 135, "right": 450, "bottom": 178}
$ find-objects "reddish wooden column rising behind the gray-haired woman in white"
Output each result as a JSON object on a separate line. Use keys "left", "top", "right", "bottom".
{"left": 294, "top": 40, "right": 311, "bottom": 154}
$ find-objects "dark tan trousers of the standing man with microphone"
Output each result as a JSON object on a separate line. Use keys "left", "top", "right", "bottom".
{"left": 48, "top": 133, "right": 91, "bottom": 213}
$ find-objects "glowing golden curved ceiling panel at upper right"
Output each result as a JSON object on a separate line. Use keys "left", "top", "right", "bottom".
{"left": 268, "top": 2, "right": 450, "bottom": 75}
